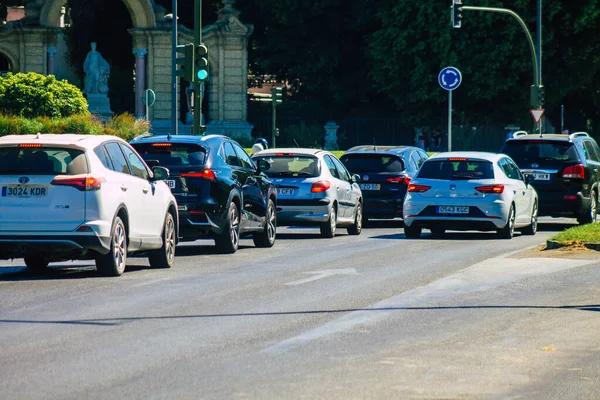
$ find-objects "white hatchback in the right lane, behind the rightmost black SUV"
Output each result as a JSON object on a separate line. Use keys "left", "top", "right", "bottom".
{"left": 404, "top": 152, "right": 538, "bottom": 239}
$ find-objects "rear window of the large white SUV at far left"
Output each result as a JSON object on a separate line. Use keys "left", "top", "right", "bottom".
{"left": 0, "top": 145, "right": 89, "bottom": 175}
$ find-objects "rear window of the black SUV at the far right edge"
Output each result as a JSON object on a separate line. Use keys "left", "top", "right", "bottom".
{"left": 501, "top": 140, "right": 579, "bottom": 165}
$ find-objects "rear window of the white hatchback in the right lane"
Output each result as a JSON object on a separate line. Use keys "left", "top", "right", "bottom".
{"left": 417, "top": 159, "right": 494, "bottom": 180}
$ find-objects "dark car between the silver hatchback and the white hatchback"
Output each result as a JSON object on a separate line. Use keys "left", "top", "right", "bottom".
{"left": 340, "top": 145, "right": 429, "bottom": 221}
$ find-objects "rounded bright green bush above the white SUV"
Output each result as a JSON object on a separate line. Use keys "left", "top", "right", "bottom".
{"left": 0, "top": 72, "right": 89, "bottom": 118}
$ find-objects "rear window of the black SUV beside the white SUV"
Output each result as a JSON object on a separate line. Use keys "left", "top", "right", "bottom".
{"left": 132, "top": 142, "right": 206, "bottom": 167}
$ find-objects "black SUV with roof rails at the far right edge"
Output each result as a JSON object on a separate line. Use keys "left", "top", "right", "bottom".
{"left": 501, "top": 132, "right": 600, "bottom": 224}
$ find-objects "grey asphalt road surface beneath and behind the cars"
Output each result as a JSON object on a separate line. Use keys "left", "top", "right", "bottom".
{"left": 0, "top": 220, "right": 600, "bottom": 400}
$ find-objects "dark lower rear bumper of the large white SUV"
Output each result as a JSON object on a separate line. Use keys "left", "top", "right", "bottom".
{"left": 0, "top": 232, "right": 110, "bottom": 261}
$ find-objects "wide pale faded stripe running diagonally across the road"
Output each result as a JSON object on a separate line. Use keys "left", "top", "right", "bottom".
{"left": 263, "top": 257, "right": 598, "bottom": 353}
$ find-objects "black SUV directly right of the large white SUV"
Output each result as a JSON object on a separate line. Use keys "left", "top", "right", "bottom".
{"left": 131, "top": 135, "right": 277, "bottom": 253}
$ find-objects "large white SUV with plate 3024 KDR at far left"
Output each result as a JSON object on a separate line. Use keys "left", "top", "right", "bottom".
{"left": 0, "top": 133, "right": 179, "bottom": 276}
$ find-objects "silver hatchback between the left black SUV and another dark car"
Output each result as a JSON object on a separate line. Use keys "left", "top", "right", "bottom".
{"left": 253, "top": 148, "right": 363, "bottom": 238}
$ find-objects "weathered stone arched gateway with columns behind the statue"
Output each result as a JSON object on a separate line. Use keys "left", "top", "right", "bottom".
{"left": 0, "top": 0, "right": 253, "bottom": 137}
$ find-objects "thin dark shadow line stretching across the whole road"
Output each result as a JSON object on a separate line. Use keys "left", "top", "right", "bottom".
{"left": 0, "top": 304, "right": 600, "bottom": 326}
